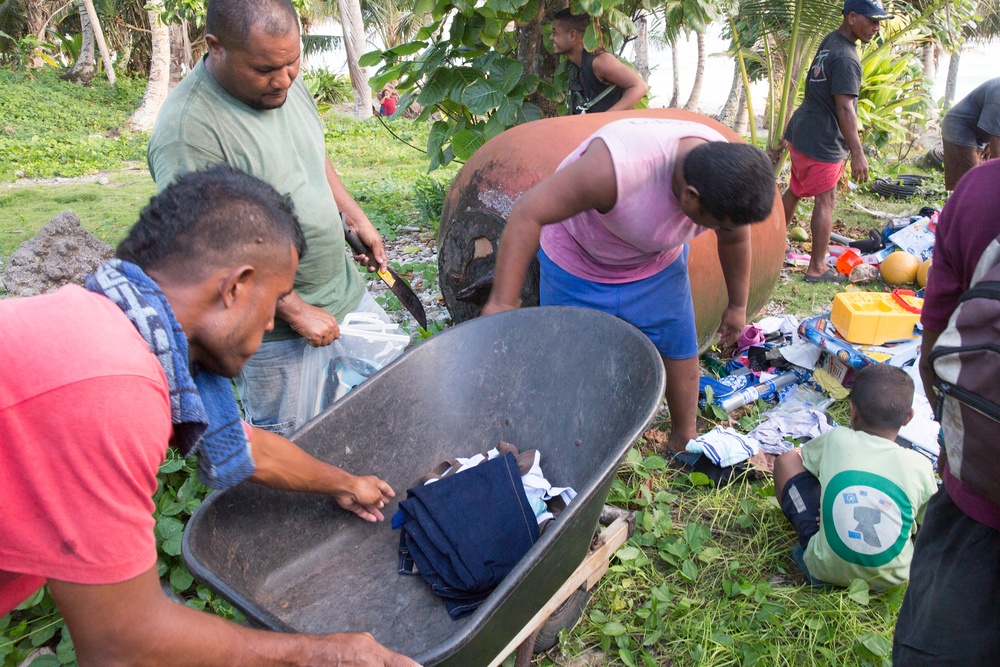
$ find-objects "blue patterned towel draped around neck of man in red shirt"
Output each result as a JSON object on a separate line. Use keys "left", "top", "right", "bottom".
{"left": 87, "top": 259, "right": 256, "bottom": 489}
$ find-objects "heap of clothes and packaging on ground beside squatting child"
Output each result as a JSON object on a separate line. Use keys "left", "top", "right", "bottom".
{"left": 688, "top": 313, "right": 939, "bottom": 485}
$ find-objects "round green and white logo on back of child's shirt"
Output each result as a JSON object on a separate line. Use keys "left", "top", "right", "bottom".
{"left": 823, "top": 470, "right": 913, "bottom": 567}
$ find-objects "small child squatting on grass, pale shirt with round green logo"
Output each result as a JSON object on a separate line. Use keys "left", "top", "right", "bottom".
{"left": 774, "top": 364, "right": 937, "bottom": 590}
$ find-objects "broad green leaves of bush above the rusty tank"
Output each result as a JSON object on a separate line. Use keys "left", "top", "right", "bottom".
{"left": 361, "top": 0, "right": 635, "bottom": 170}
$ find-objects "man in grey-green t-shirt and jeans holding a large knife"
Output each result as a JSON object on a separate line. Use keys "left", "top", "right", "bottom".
{"left": 147, "top": 0, "right": 389, "bottom": 436}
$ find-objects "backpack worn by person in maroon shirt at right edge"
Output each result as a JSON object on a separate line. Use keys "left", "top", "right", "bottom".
{"left": 928, "top": 237, "right": 1000, "bottom": 505}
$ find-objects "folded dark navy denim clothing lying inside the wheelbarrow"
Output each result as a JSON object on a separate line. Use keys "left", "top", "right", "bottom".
{"left": 393, "top": 454, "right": 539, "bottom": 619}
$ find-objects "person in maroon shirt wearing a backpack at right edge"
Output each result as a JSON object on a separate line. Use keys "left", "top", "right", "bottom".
{"left": 892, "top": 160, "right": 1000, "bottom": 667}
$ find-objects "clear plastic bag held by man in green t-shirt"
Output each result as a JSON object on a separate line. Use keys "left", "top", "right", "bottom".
{"left": 296, "top": 312, "right": 410, "bottom": 426}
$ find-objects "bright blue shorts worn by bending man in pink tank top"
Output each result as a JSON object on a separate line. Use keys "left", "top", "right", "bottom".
{"left": 538, "top": 244, "right": 698, "bottom": 359}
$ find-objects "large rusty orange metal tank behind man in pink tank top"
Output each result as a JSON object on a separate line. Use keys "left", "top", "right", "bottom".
{"left": 438, "top": 109, "right": 785, "bottom": 346}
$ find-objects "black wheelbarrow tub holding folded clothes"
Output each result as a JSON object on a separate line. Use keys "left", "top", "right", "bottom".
{"left": 184, "top": 307, "right": 664, "bottom": 667}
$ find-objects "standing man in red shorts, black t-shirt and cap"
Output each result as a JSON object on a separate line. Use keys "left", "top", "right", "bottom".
{"left": 781, "top": 0, "right": 893, "bottom": 283}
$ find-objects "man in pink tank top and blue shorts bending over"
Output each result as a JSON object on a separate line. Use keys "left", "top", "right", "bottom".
{"left": 483, "top": 118, "right": 775, "bottom": 451}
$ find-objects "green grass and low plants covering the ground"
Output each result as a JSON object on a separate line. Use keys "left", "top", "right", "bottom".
{"left": 0, "top": 69, "right": 940, "bottom": 667}
